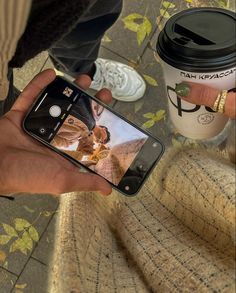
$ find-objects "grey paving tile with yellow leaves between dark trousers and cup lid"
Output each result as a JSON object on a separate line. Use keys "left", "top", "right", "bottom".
{"left": 102, "top": 0, "right": 162, "bottom": 60}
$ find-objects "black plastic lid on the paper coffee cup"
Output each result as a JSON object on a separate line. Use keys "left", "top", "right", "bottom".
{"left": 157, "top": 7, "right": 236, "bottom": 72}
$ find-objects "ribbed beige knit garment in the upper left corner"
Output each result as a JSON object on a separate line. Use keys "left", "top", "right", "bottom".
{"left": 0, "top": 0, "right": 31, "bottom": 101}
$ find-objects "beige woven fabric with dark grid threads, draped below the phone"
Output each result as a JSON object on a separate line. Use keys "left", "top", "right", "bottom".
{"left": 49, "top": 150, "right": 235, "bottom": 293}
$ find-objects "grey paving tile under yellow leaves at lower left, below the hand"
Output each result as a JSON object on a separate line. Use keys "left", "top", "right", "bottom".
{"left": 0, "top": 195, "right": 58, "bottom": 275}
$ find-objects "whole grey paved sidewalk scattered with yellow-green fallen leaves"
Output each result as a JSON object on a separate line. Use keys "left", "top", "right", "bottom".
{"left": 0, "top": 0, "right": 235, "bottom": 293}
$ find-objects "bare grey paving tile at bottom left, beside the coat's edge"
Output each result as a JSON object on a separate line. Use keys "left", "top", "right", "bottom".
{"left": 15, "top": 258, "right": 48, "bottom": 293}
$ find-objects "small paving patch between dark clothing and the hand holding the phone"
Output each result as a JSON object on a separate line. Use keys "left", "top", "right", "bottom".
{"left": 14, "top": 52, "right": 48, "bottom": 91}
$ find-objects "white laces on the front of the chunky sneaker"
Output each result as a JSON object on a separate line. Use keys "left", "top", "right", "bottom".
{"left": 97, "top": 64, "right": 125, "bottom": 89}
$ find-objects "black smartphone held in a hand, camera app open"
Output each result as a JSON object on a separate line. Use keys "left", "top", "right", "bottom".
{"left": 23, "top": 77, "right": 164, "bottom": 196}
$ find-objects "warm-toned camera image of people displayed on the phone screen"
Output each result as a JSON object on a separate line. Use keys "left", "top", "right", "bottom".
{"left": 51, "top": 96, "right": 148, "bottom": 185}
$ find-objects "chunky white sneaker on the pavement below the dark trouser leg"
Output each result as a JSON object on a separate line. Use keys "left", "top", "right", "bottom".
{"left": 90, "top": 58, "right": 146, "bottom": 102}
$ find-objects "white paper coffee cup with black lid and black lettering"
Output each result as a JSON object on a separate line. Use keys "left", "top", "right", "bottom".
{"left": 157, "top": 7, "right": 236, "bottom": 139}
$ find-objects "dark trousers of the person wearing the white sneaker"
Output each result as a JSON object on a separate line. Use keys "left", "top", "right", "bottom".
{"left": 0, "top": 0, "right": 122, "bottom": 116}
